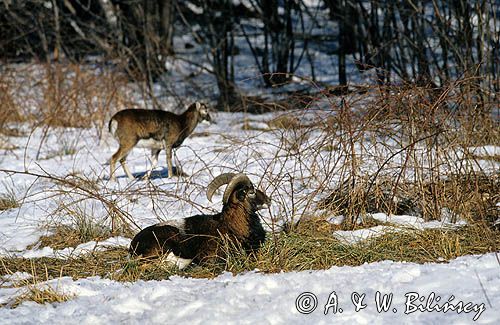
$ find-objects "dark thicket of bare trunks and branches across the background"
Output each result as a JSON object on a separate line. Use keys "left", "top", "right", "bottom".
{"left": 0, "top": 0, "right": 500, "bottom": 107}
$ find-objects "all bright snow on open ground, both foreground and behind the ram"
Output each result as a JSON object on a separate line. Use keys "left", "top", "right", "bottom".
{"left": 0, "top": 108, "right": 500, "bottom": 324}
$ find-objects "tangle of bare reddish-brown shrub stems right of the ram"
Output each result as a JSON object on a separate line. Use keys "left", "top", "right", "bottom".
{"left": 270, "top": 79, "right": 500, "bottom": 229}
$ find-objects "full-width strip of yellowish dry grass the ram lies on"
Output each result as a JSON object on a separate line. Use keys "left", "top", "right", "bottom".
{"left": 0, "top": 225, "right": 500, "bottom": 281}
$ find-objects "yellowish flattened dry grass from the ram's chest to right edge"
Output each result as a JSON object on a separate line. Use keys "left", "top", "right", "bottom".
{"left": 226, "top": 221, "right": 500, "bottom": 273}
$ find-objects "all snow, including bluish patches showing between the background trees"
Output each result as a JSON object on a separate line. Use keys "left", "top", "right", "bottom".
{"left": 0, "top": 10, "right": 500, "bottom": 324}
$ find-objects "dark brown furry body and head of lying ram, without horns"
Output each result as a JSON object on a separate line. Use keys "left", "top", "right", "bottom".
{"left": 130, "top": 185, "right": 270, "bottom": 263}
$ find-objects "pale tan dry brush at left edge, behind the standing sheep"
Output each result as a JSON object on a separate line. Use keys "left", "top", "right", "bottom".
{"left": 0, "top": 63, "right": 131, "bottom": 130}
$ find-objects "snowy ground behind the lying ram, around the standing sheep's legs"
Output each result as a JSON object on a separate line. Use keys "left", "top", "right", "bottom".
{"left": 0, "top": 112, "right": 500, "bottom": 256}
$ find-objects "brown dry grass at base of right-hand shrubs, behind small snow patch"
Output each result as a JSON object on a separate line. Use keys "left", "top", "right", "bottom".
{"left": 318, "top": 173, "right": 500, "bottom": 223}
